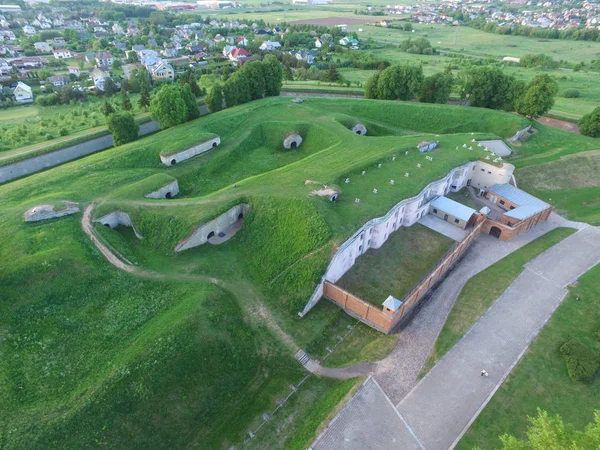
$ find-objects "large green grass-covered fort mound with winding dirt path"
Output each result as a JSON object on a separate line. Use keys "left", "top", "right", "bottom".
{"left": 0, "top": 98, "right": 597, "bottom": 449}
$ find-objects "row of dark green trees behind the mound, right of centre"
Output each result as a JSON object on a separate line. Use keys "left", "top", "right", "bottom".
{"left": 365, "top": 64, "right": 558, "bottom": 118}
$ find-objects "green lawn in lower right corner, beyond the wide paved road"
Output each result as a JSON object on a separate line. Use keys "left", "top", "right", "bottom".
{"left": 457, "top": 265, "right": 600, "bottom": 450}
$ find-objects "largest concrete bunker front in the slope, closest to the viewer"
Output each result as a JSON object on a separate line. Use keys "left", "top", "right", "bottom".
{"left": 175, "top": 203, "right": 250, "bottom": 252}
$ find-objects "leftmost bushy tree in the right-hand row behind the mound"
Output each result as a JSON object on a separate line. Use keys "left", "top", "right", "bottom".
{"left": 377, "top": 64, "right": 424, "bottom": 100}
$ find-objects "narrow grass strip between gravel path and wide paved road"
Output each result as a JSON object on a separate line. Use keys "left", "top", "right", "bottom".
{"left": 421, "top": 228, "right": 575, "bottom": 375}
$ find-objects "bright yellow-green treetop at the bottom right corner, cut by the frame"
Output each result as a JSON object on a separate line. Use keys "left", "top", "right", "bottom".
{"left": 500, "top": 408, "right": 600, "bottom": 450}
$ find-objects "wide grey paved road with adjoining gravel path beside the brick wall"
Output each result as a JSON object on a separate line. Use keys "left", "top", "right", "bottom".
{"left": 312, "top": 223, "right": 600, "bottom": 450}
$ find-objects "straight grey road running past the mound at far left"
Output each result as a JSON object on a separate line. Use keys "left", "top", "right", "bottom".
{"left": 0, "top": 122, "right": 159, "bottom": 183}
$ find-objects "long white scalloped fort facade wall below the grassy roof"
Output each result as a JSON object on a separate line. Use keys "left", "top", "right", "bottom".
{"left": 298, "top": 162, "right": 478, "bottom": 317}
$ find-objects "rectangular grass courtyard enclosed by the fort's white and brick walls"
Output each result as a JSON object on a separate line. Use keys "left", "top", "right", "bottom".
{"left": 336, "top": 224, "right": 454, "bottom": 307}
